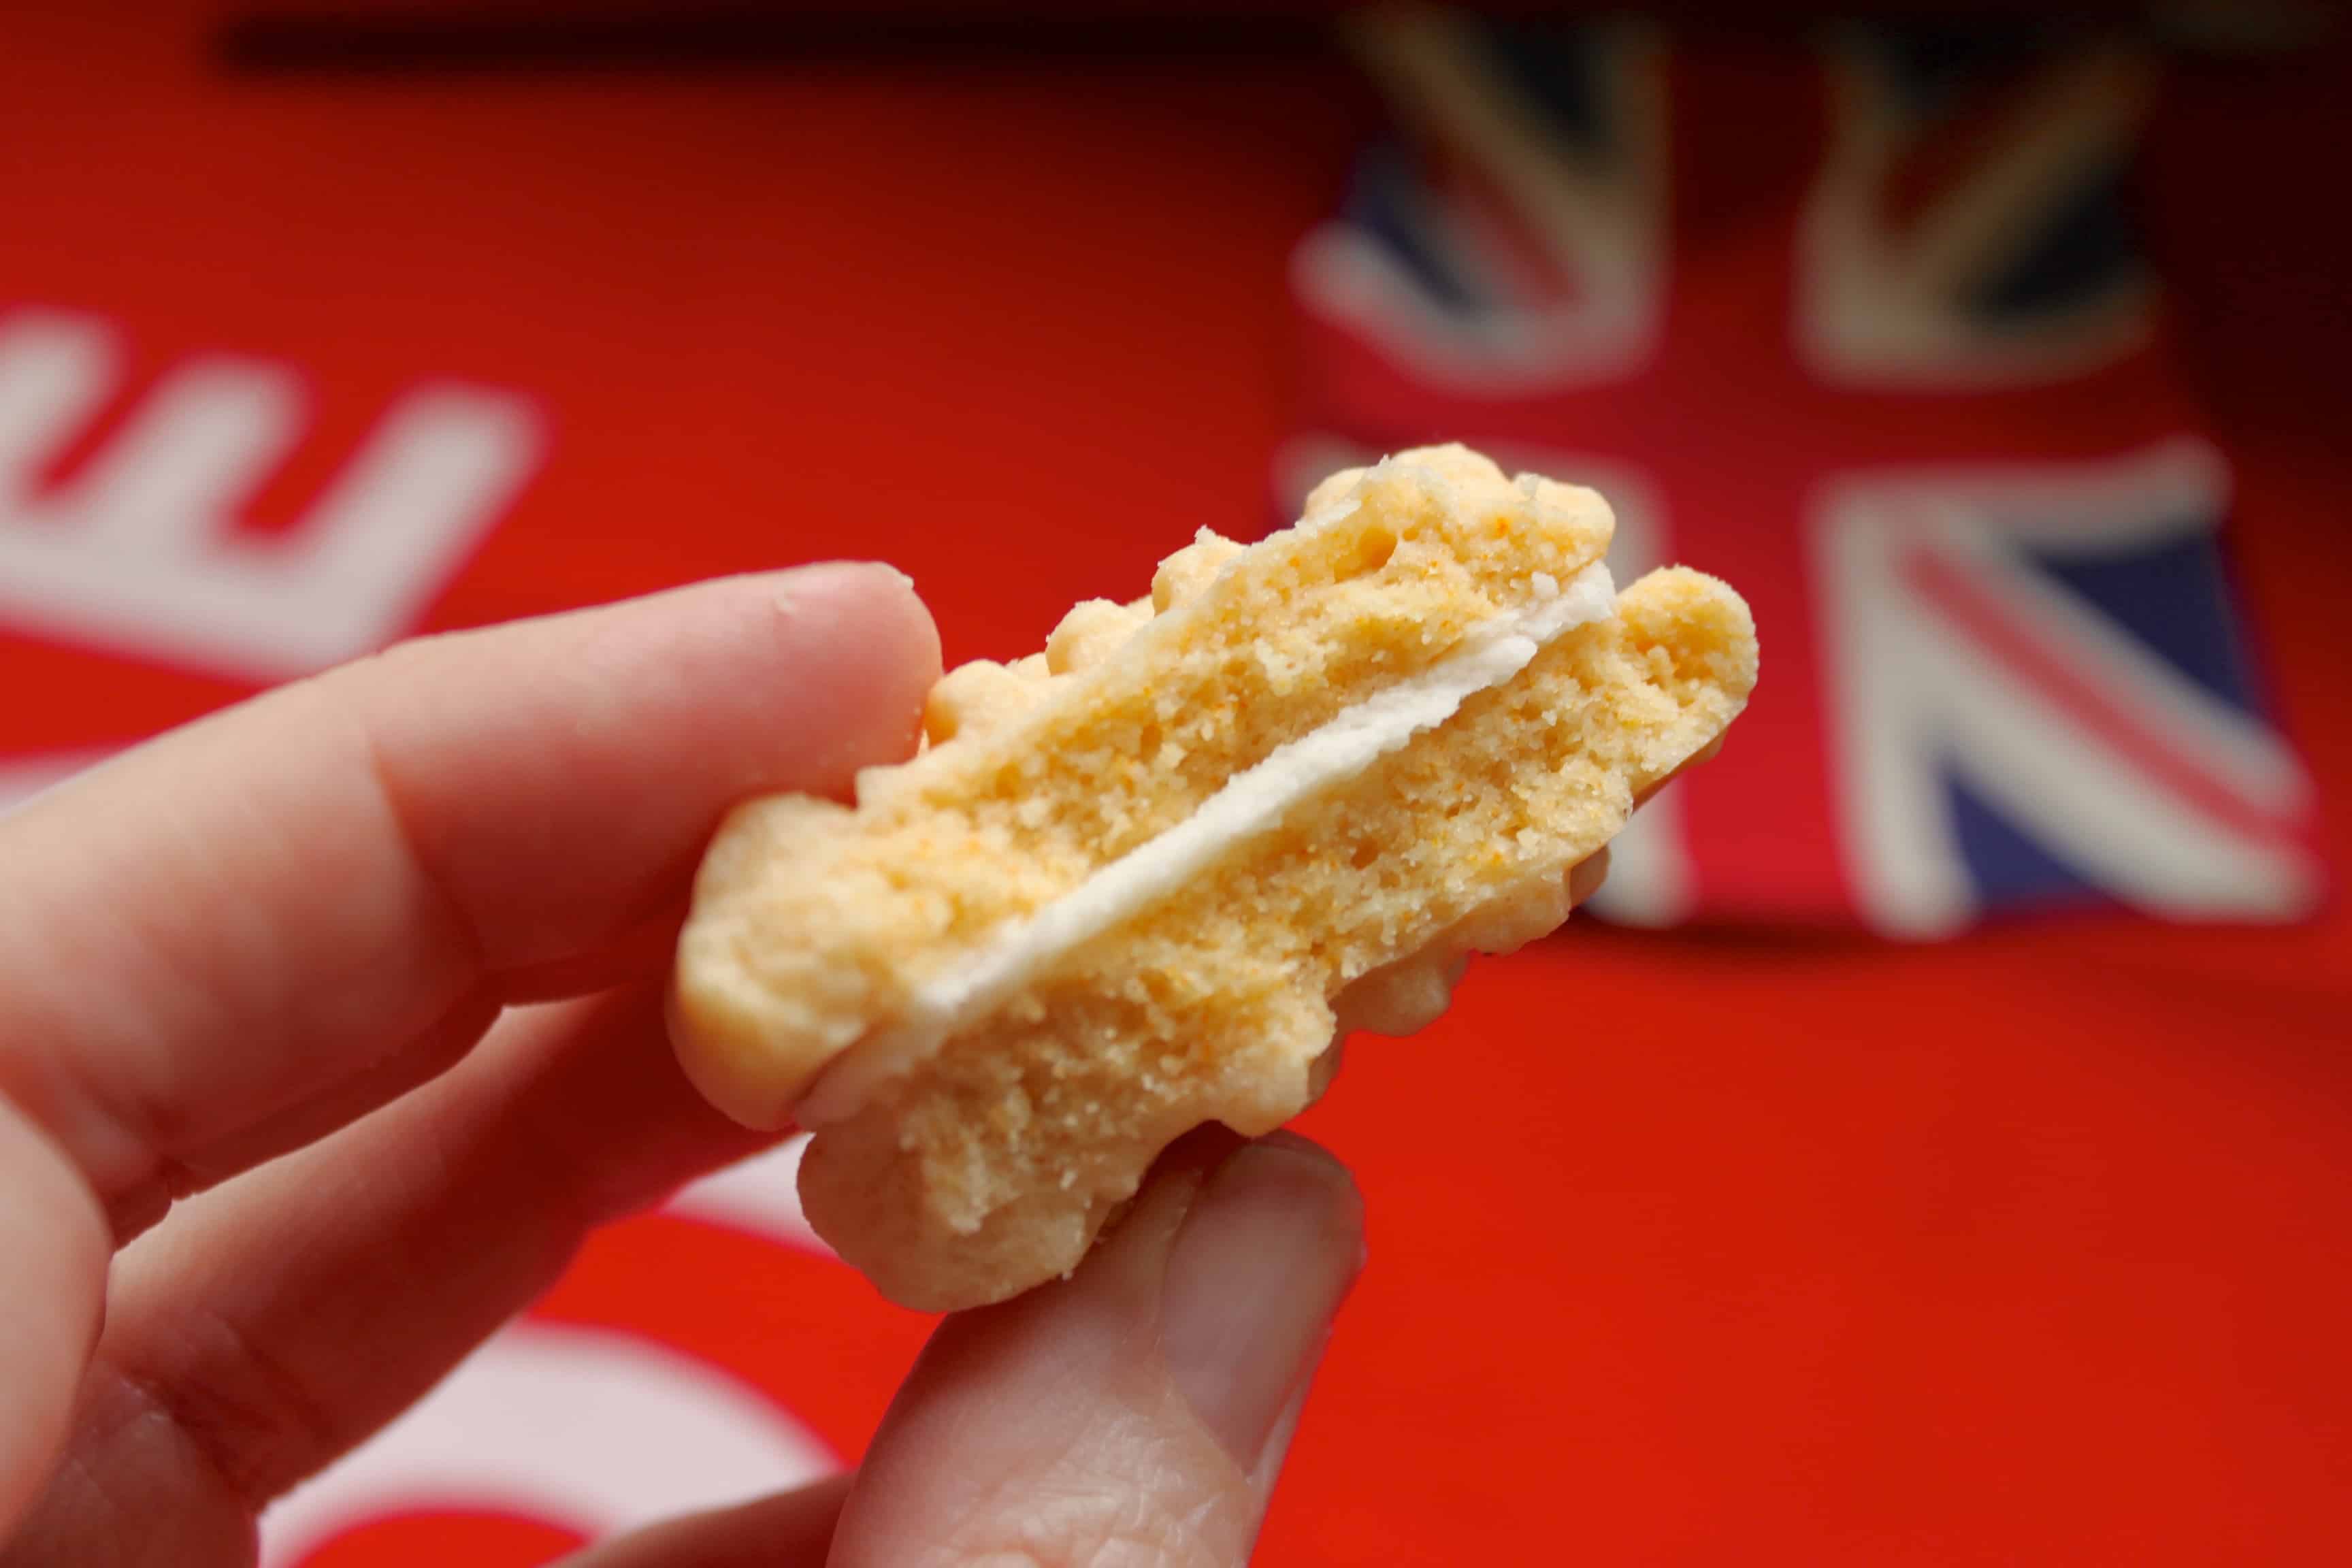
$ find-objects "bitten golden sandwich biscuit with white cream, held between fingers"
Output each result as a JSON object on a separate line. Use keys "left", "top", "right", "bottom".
{"left": 672, "top": 446, "right": 1757, "bottom": 1309}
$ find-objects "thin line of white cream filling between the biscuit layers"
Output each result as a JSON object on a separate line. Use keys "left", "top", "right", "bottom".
{"left": 798, "top": 562, "right": 1616, "bottom": 1126}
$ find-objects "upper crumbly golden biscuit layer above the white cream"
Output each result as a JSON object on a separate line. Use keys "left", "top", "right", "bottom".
{"left": 677, "top": 446, "right": 1611, "bottom": 1126}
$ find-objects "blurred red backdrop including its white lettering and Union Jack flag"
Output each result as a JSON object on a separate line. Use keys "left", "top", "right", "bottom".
{"left": 0, "top": 0, "right": 2352, "bottom": 1568}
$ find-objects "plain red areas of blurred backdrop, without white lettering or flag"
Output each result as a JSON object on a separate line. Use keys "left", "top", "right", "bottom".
{"left": 0, "top": 2, "right": 2352, "bottom": 1563}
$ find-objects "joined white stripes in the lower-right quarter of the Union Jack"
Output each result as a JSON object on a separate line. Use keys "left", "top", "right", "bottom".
{"left": 1816, "top": 442, "right": 2319, "bottom": 936}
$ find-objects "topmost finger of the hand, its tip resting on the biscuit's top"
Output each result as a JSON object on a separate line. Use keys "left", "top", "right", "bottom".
{"left": 0, "top": 564, "right": 938, "bottom": 1204}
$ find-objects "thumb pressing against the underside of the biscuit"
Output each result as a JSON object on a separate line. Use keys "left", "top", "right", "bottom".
{"left": 830, "top": 1128, "right": 1364, "bottom": 1568}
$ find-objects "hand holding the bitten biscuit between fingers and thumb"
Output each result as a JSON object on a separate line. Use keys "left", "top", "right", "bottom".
{"left": 0, "top": 566, "right": 1362, "bottom": 1568}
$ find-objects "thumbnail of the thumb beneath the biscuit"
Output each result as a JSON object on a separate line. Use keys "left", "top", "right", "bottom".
{"left": 1160, "top": 1133, "right": 1364, "bottom": 1471}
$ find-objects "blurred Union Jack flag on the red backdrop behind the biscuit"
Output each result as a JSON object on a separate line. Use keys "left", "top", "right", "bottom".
{"left": 1282, "top": 10, "right": 2321, "bottom": 936}
